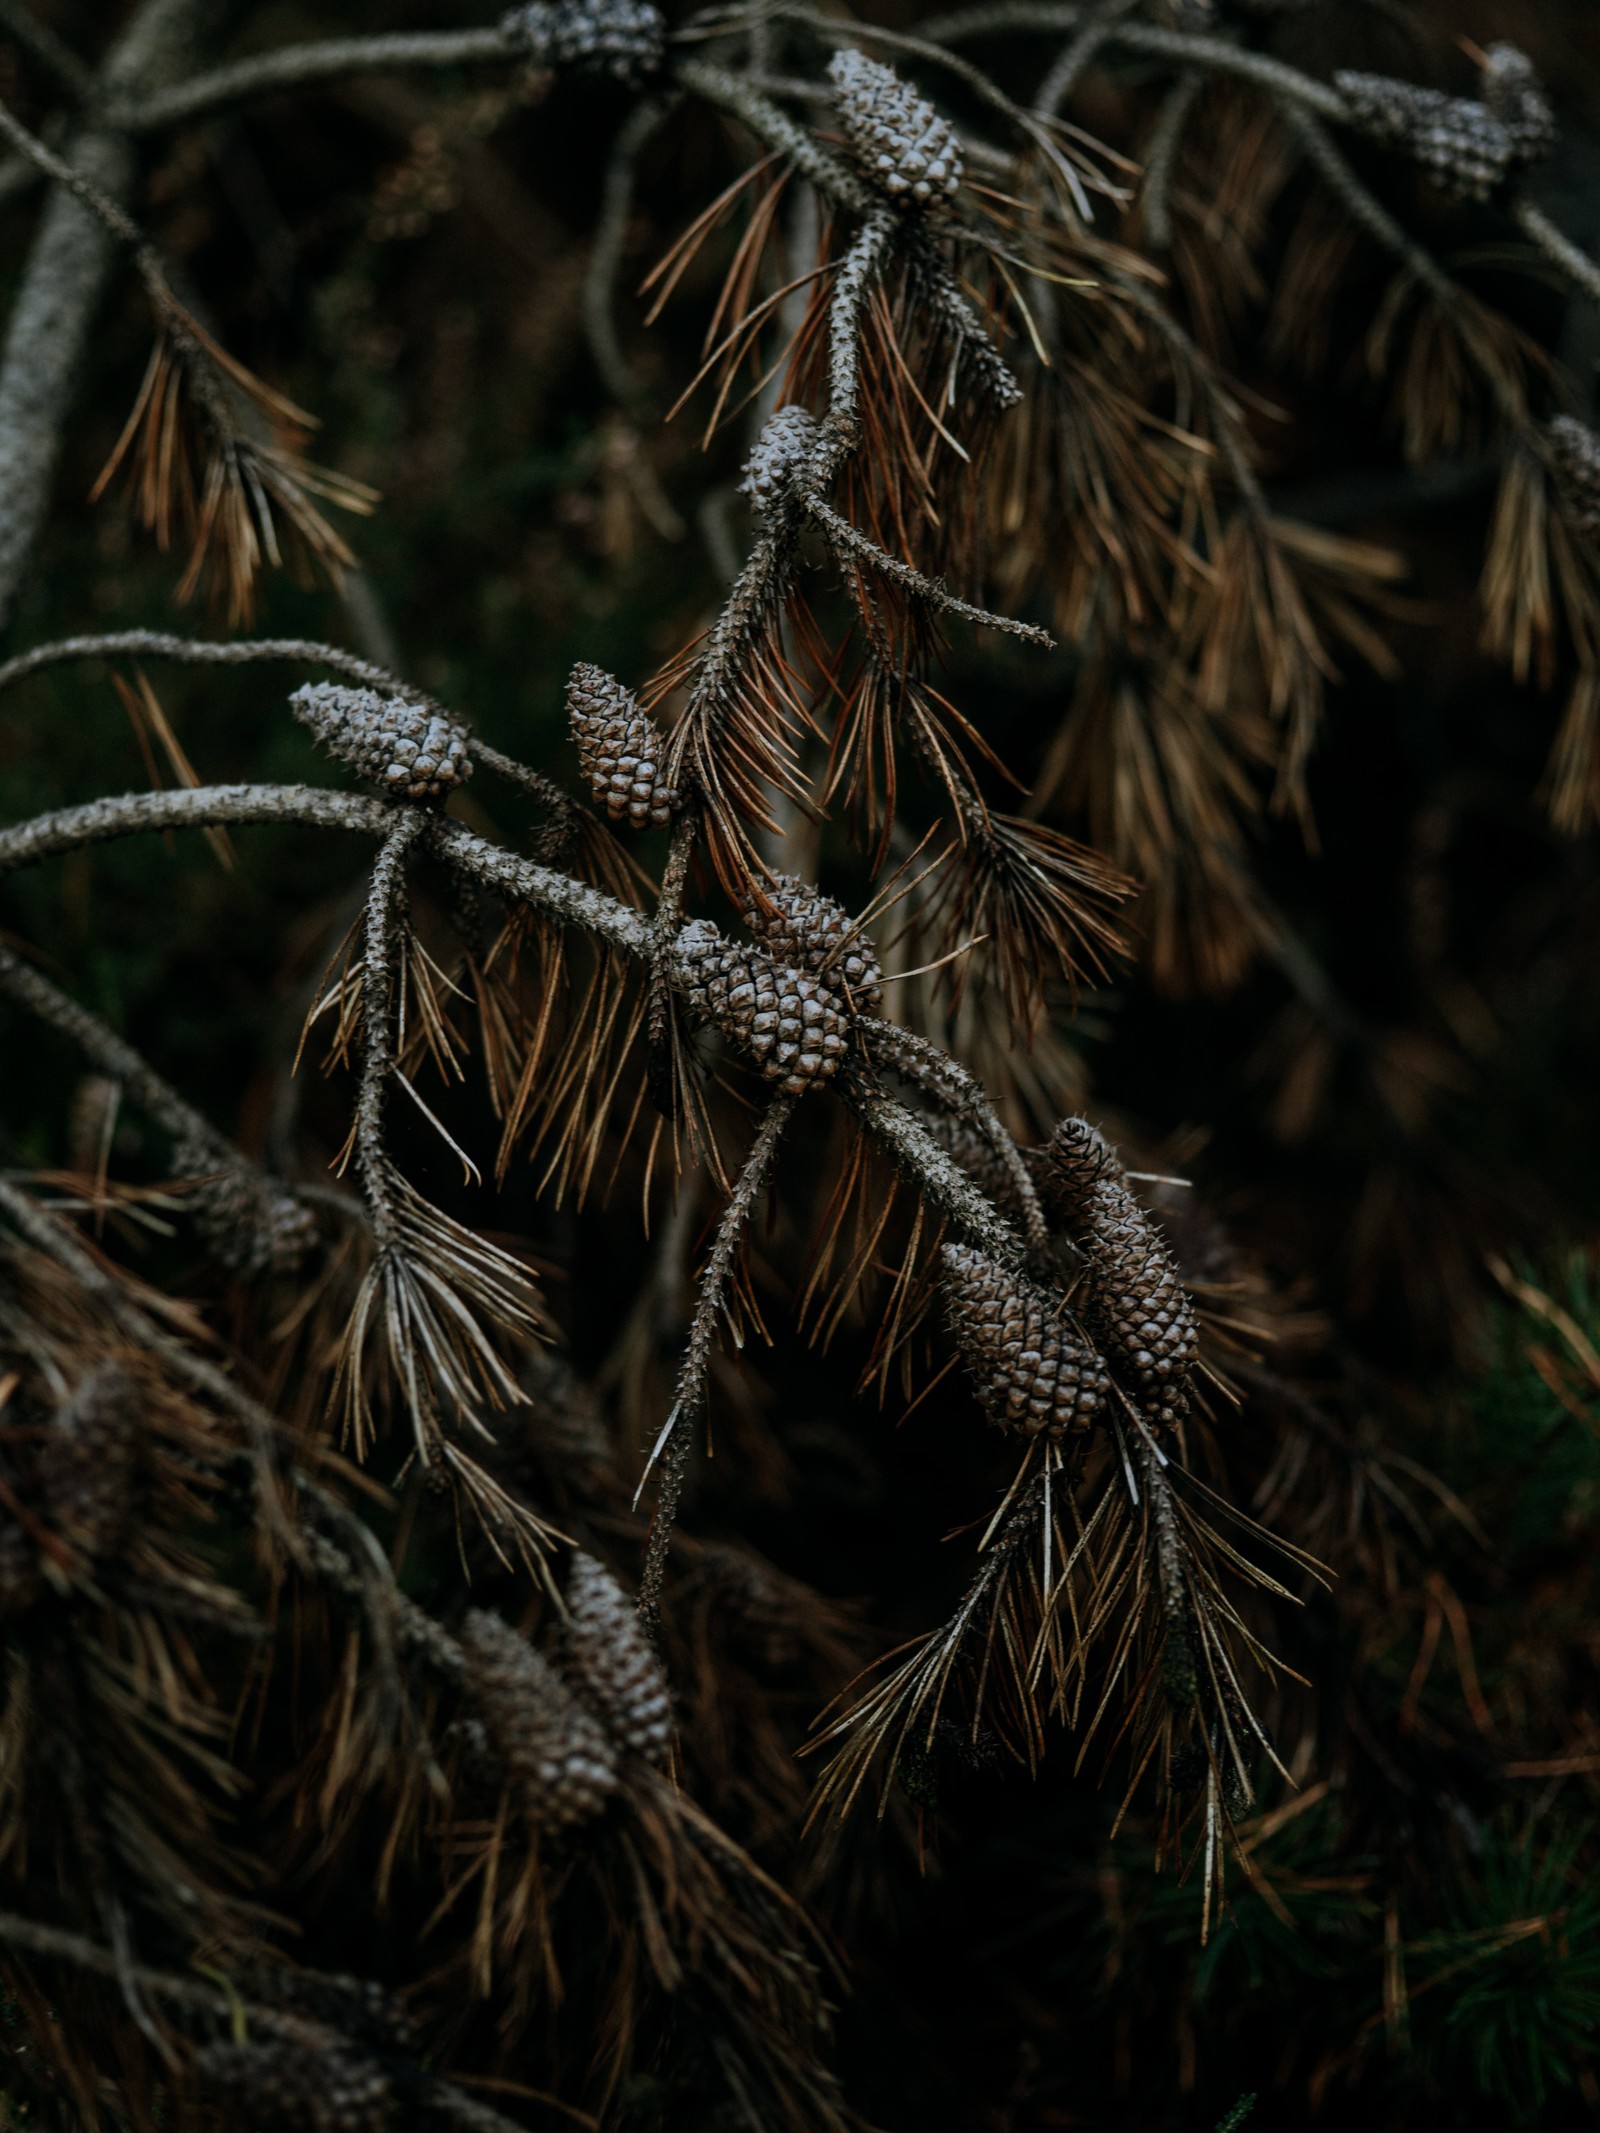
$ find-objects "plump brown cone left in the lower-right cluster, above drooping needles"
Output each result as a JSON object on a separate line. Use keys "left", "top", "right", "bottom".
{"left": 941, "top": 1244, "right": 1107, "bottom": 1438}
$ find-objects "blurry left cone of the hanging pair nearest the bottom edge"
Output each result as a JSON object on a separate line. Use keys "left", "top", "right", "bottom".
{"left": 461, "top": 1613, "right": 617, "bottom": 1830}
